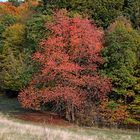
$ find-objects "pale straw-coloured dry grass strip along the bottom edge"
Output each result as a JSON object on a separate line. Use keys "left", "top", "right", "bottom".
{"left": 0, "top": 114, "right": 132, "bottom": 140}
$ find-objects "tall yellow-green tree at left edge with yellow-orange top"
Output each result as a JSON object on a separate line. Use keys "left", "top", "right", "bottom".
{"left": 0, "top": 23, "right": 33, "bottom": 91}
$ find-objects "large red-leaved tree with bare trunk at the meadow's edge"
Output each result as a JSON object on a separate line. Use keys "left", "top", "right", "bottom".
{"left": 19, "top": 10, "right": 111, "bottom": 121}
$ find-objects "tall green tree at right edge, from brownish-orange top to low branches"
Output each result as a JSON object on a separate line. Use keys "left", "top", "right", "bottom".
{"left": 102, "top": 18, "right": 140, "bottom": 124}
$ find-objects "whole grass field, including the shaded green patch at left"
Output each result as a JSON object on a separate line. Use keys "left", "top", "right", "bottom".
{"left": 0, "top": 93, "right": 140, "bottom": 140}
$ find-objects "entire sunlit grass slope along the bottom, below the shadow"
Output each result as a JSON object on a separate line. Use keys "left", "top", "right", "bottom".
{"left": 0, "top": 114, "right": 140, "bottom": 140}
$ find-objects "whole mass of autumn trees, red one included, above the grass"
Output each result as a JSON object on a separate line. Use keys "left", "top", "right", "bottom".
{"left": 0, "top": 0, "right": 140, "bottom": 127}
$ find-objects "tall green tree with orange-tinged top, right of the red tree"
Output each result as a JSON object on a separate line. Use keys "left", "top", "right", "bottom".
{"left": 103, "top": 20, "right": 140, "bottom": 97}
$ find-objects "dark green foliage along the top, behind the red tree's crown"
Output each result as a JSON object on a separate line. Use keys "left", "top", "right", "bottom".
{"left": 44, "top": 0, "right": 140, "bottom": 28}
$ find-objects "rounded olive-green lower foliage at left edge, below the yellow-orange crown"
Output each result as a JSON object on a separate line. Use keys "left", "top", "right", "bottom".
{"left": 0, "top": 48, "right": 33, "bottom": 91}
